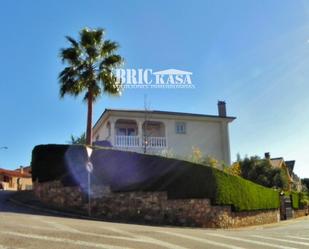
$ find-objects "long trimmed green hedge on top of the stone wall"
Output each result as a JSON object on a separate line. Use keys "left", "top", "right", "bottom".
{"left": 31, "top": 145, "right": 280, "bottom": 211}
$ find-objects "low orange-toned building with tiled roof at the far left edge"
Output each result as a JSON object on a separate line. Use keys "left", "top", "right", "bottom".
{"left": 0, "top": 167, "right": 32, "bottom": 190}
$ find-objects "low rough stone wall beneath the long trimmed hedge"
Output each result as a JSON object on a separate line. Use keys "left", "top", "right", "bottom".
{"left": 34, "top": 181, "right": 279, "bottom": 228}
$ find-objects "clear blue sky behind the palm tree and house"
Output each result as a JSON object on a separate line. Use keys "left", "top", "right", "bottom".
{"left": 0, "top": 0, "right": 309, "bottom": 178}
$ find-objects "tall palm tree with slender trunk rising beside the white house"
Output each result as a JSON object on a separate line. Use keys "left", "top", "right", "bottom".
{"left": 59, "top": 28, "right": 123, "bottom": 145}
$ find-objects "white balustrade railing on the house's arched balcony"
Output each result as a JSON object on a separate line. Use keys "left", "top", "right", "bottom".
{"left": 115, "top": 135, "right": 167, "bottom": 148}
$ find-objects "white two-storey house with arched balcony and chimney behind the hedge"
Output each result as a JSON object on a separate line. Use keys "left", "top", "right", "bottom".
{"left": 93, "top": 101, "right": 235, "bottom": 164}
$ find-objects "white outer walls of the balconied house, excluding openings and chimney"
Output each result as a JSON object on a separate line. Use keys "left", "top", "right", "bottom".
{"left": 93, "top": 110, "right": 232, "bottom": 164}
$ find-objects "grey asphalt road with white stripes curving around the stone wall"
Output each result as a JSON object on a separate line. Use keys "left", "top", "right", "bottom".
{"left": 0, "top": 191, "right": 309, "bottom": 249}
